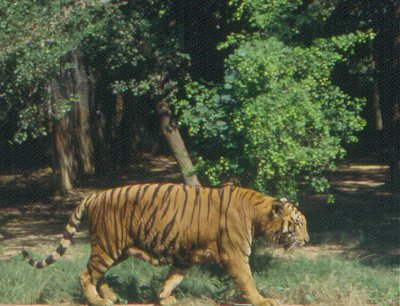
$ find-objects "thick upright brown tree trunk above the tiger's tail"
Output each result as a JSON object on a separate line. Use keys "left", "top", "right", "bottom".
{"left": 49, "top": 51, "right": 94, "bottom": 193}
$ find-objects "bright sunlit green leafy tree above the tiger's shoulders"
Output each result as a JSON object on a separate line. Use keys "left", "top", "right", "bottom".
{"left": 175, "top": 1, "right": 371, "bottom": 200}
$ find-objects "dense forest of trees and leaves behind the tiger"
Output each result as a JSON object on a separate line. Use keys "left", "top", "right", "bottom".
{"left": 0, "top": 0, "right": 400, "bottom": 200}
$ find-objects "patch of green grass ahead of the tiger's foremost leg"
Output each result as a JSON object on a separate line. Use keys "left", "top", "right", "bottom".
{"left": 254, "top": 255, "right": 399, "bottom": 305}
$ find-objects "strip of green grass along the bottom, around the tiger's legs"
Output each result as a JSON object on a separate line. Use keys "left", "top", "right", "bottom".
{"left": 0, "top": 246, "right": 400, "bottom": 306}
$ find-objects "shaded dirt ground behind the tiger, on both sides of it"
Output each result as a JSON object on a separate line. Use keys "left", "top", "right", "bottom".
{"left": 0, "top": 157, "right": 400, "bottom": 264}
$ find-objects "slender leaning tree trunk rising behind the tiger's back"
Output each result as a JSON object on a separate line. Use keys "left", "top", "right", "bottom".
{"left": 157, "top": 99, "right": 201, "bottom": 186}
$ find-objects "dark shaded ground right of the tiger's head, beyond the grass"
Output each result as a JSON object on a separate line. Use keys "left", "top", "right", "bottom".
{"left": 301, "top": 164, "right": 400, "bottom": 265}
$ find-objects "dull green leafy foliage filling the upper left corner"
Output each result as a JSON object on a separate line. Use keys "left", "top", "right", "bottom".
{"left": 0, "top": 0, "right": 106, "bottom": 143}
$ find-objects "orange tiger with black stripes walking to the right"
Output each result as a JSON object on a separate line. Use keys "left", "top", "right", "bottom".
{"left": 22, "top": 183, "right": 309, "bottom": 306}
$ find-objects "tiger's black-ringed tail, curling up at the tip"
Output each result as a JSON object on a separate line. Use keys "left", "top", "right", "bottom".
{"left": 22, "top": 196, "right": 92, "bottom": 269}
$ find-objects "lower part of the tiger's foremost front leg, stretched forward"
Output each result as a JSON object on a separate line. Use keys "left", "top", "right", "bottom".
{"left": 222, "top": 255, "right": 279, "bottom": 306}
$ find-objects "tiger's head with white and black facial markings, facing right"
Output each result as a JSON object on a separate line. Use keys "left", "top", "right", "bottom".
{"left": 263, "top": 199, "right": 309, "bottom": 251}
